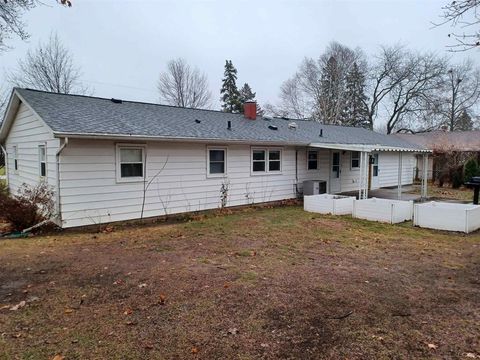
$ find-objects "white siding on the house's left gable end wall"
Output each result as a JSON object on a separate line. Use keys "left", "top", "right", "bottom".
{"left": 5, "top": 103, "right": 60, "bottom": 193}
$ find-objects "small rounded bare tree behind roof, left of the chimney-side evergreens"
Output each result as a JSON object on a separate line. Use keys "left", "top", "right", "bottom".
{"left": 158, "top": 58, "right": 212, "bottom": 108}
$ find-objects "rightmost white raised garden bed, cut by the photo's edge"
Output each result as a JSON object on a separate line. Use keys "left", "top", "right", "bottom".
{"left": 413, "top": 201, "right": 480, "bottom": 233}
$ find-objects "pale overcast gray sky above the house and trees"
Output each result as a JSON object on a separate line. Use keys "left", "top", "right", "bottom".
{"left": 0, "top": 0, "right": 480, "bottom": 107}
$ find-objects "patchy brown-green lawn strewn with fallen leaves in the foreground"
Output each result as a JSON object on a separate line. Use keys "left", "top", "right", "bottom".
{"left": 0, "top": 207, "right": 480, "bottom": 359}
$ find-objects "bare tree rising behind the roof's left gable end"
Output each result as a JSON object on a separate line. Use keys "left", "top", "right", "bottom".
{"left": 7, "top": 34, "right": 88, "bottom": 94}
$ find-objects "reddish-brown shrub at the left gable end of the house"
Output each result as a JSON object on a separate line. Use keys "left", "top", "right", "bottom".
{"left": 0, "top": 182, "right": 54, "bottom": 231}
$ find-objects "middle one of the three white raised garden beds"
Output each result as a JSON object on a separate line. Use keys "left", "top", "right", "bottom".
{"left": 353, "top": 198, "right": 413, "bottom": 224}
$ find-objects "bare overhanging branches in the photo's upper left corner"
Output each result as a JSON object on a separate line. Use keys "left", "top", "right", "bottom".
{"left": 0, "top": 0, "right": 72, "bottom": 52}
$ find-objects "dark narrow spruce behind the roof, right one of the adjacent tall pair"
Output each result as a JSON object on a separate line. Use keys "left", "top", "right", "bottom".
{"left": 341, "top": 63, "right": 370, "bottom": 128}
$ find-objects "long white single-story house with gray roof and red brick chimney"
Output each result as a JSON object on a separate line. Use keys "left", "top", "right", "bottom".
{"left": 0, "top": 88, "right": 425, "bottom": 227}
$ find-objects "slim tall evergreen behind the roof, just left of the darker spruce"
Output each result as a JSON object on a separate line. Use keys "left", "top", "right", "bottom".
{"left": 319, "top": 56, "right": 342, "bottom": 124}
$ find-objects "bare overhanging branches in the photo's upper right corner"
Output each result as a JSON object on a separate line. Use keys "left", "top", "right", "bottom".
{"left": 436, "top": 0, "right": 480, "bottom": 51}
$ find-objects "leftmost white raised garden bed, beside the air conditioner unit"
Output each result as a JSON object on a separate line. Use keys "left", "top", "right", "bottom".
{"left": 303, "top": 194, "right": 355, "bottom": 215}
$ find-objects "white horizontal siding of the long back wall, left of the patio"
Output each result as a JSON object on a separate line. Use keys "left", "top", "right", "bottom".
{"left": 60, "top": 139, "right": 302, "bottom": 227}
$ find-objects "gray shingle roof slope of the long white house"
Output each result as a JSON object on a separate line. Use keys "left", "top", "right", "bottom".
{"left": 16, "top": 89, "right": 422, "bottom": 149}
